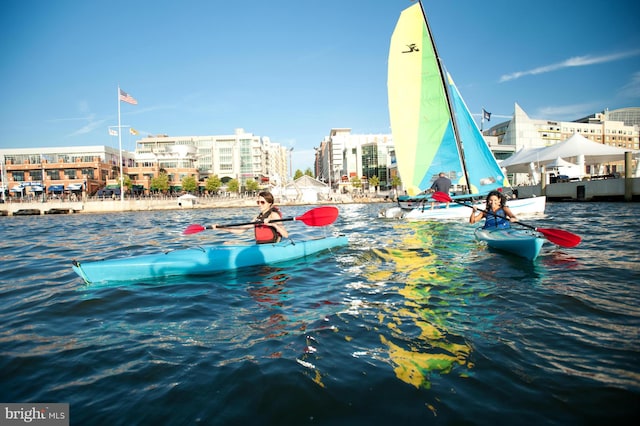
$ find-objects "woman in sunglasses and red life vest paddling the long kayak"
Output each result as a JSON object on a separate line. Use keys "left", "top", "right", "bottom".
{"left": 212, "top": 191, "right": 289, "bottom": 244}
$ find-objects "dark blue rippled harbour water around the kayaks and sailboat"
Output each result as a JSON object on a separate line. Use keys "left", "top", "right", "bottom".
{"left": 0, "top": 203, "right": 640, "bottom": 425}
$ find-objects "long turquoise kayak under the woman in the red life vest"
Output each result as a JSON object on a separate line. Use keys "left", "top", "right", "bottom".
{"left": 72, "top": 235, "right": 349, "bottom": 284}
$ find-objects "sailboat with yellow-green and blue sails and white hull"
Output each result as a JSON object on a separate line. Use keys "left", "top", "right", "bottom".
{"left": 380, "top": 1, "right": 546, "bottom": 220}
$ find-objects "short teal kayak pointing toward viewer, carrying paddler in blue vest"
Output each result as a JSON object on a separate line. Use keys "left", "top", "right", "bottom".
{"left": 476, "top": 228, "right": 546, "bottom": 260}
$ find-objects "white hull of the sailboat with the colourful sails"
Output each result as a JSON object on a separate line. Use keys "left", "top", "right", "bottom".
{"left": 379, "top": 196, "right": 547, "bottom": 221}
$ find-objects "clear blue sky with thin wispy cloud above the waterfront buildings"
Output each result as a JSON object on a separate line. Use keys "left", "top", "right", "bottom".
{"left": 0, "top": 0, "right": 640, "bottom": 175}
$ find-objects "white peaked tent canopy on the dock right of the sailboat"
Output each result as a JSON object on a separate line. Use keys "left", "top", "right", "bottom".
{"left": 500, "top": 133, "right": 638, "bottom": 173}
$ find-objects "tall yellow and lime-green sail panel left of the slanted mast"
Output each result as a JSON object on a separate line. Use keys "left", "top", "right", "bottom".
{"left": 387, "top": 3, "right": 457, "bottom": 195}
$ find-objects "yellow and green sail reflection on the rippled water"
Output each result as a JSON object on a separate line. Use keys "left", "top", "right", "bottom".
{"left": 342, "top": 223, "right": 473, "bottom": 388}
